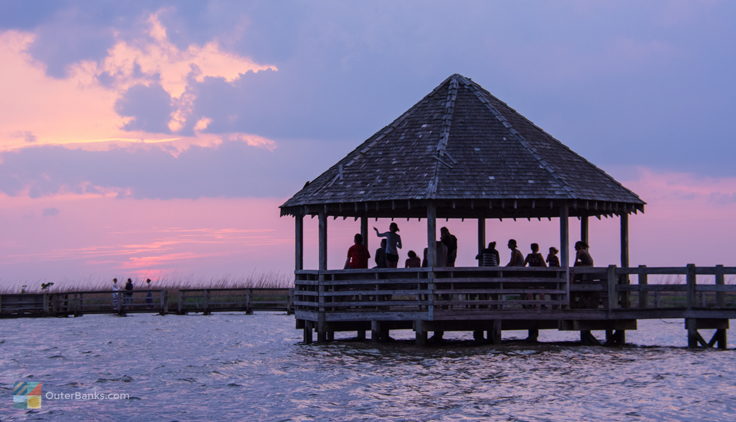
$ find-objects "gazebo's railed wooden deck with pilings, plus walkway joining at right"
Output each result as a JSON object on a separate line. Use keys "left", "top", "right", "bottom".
{"left": 294, "top": 265, "right": 736, "bottom": 348}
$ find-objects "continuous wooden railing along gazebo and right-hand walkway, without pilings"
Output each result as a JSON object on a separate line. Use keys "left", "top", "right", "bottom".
{"left": 294, "top": 264, "right": 736, "bottom": 320}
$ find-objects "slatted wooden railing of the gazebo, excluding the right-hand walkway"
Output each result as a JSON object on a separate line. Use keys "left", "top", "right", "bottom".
{"left": 294, "top": 267, "right": 568, "bottom": 319}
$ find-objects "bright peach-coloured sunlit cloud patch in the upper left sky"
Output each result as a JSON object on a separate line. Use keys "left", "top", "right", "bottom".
{"left": 0, "top": 10, "right": 277, "bottom": 154}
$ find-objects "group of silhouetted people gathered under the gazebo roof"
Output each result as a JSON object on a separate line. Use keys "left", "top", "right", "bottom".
{"left": 345, "top": 223, "right": 593, "bottom": 269}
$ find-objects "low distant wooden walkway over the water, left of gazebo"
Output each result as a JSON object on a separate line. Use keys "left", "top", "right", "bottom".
{"left": 0, "top": 288, "right": 293, "bottom": 318}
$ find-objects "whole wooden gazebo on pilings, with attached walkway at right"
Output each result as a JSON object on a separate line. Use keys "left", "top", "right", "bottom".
{"left": 280, "top": 74, "right": 736, "bottom": 348}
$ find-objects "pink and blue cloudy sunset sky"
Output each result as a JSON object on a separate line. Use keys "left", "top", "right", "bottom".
{"left": 0, "top": 0, "right": 736, "bottom": 286}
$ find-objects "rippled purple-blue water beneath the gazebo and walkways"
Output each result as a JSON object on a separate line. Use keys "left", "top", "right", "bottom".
{"left": 0, "top": 313, "right": 736, "bottom": 421}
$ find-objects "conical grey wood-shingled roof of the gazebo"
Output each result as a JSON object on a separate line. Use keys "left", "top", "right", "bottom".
{"left": 281, "top": 74, "right": 644, "bottom": 218}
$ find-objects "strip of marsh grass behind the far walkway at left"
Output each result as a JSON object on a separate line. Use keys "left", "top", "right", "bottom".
{"left": 0, "top": 272, "right": 294, "bottom": 294}
